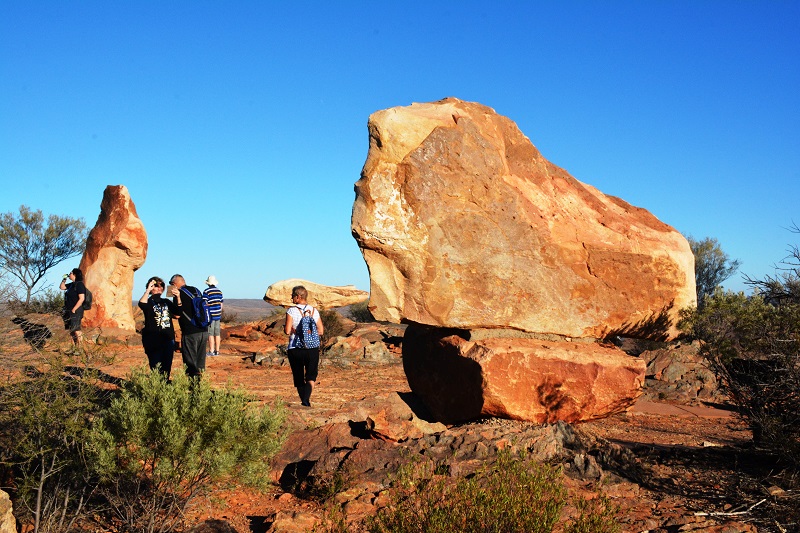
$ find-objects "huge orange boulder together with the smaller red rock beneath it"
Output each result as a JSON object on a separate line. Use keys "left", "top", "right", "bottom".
{"left": 351, "top": 98, "right": 696, "bottom": 422}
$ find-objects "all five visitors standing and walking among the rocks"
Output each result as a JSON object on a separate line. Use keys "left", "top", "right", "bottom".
{"left": 59, "top": 268, "right": 325, "bottom": 407}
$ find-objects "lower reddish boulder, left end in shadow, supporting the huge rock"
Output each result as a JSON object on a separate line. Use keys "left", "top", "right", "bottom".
{"left": 403, "top": 326, "right": 645, "bottom": 423}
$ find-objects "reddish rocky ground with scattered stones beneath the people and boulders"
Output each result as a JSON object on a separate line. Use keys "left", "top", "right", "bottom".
{"left": 0, "top": 319, "right": 800, "bottom": 533}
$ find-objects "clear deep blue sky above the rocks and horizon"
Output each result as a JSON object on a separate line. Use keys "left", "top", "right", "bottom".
{"left": 0, "top": 0, "right": 800, "bottom": 298}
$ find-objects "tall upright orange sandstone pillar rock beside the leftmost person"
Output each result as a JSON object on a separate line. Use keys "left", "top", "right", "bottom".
{"left": 80, "top": 185, "right": 147, "bottom": 331}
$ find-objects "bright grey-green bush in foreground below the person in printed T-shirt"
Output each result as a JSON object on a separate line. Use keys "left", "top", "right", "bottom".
{"left": 89, "top": 370, "right": 286, "bottom": 532}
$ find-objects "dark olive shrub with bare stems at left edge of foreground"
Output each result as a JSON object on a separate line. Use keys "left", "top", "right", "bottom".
{"left": 0, "top": 353, "right": 108, "bottom": 533}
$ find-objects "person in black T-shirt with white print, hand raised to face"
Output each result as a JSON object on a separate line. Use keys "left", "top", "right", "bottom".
{"left": 139, "top": 276, "right": 180, "bottom": 379}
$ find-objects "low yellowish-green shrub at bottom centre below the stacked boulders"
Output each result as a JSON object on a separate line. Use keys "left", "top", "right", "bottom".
{"left": 367, "top": 453, "right": 567, "bottom": 533}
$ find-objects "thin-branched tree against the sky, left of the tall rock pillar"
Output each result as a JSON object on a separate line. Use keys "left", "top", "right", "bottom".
{"left": 0, "top": 205, "right": 87, "bottom": 304}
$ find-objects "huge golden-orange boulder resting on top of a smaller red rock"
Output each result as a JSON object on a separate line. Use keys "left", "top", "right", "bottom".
{"left": 352, "top": 98, "right": 696, "bottom": 338}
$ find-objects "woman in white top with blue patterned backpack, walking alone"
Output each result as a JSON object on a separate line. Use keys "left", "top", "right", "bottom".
{"left": 283, "top": 285, "right": 325, "bottom": 407}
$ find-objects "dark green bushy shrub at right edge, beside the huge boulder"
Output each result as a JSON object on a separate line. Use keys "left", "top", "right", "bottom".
{"left": 680, "top": 290, "right": 800, "bottom": 465}
